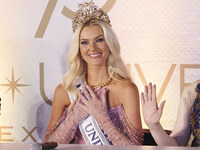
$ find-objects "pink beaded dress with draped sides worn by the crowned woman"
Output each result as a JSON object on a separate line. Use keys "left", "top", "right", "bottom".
{"left": 45, "top": 79, "right": 144, "bottom": 145}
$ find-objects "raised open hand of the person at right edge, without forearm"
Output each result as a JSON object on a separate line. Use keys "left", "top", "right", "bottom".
{"left": 141, "top": 83, "right": 165, "bottom": 128}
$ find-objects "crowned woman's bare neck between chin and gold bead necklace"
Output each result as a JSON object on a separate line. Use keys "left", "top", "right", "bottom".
{"left": 86, "top": 66, "right": 109, "bottom": 86}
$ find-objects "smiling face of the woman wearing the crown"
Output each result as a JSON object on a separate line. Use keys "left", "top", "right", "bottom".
{"left": 80, "top": 25, "right": 109, "bottom": 65}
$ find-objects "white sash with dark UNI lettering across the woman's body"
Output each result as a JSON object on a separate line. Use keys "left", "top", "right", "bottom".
{"left": 68, "top": 78, "right": 110, "bottom": 145}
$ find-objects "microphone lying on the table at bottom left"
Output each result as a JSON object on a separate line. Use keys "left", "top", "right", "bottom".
{"left": 30, "top": 142, "right": 58, "bottom": 150}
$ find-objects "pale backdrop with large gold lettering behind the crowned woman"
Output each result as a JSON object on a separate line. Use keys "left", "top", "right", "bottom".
{"left": 0, "top": 0, "right": 200, "bottom": 142}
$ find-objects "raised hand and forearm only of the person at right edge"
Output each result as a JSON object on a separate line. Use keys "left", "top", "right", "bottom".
{"left": 141, "top": 83, "right": 178, "bottom": 146}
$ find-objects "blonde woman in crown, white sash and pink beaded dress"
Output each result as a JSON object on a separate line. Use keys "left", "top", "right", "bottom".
{"left": 45, "top": 1, "right": 143, "bottom": 145}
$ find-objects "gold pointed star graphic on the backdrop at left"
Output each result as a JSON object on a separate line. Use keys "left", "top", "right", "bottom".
{"left": 0, "top": 68, "right": 30, "bottom": 103}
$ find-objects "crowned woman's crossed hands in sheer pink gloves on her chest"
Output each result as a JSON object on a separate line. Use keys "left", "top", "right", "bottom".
{"left": 79, "top": 85, "right": 108, "bottom": 117}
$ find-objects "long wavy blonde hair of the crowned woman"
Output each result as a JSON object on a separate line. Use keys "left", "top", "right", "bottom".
{"left": 63, "top": 20, "right": 131, "bottom": 108}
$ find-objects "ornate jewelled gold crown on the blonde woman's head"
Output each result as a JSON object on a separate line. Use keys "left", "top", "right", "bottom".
{"left": 72, "top": 0, "right": 111, "bottom": 32}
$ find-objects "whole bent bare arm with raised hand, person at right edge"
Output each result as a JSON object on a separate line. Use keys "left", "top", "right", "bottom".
{"left": 141, "top": 83, "right": 195, "bottom": 146}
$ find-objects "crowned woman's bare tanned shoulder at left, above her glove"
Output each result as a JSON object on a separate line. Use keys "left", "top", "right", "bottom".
{"left": 53, "top": 84, "right": 70, "bottom": 106}
